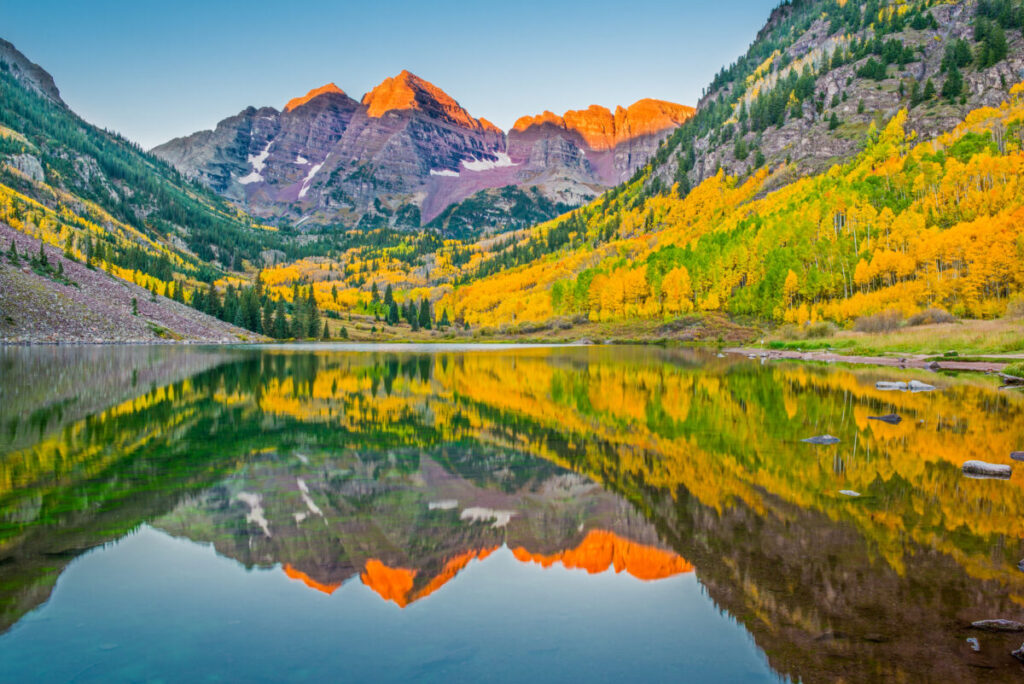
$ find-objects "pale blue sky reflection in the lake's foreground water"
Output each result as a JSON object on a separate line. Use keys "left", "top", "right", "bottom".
{"left": 0, "top": 526, "right": 776, "bottom": 682}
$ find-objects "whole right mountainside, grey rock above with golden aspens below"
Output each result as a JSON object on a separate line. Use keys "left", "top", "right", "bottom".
{"left": 436, "top": 0, "right": 1024, "bottom": 335}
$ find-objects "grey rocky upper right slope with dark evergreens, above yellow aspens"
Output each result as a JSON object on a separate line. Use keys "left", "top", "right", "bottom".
{"left": 649, "top": 0, "right": 1024, "bottom": 193}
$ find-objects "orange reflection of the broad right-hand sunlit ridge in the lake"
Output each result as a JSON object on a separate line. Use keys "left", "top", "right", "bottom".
{"left": 512, "top": 529, "right": 693, "bottom": 581}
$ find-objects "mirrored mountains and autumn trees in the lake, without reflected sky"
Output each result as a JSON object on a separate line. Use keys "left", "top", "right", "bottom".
{"left": 0, "top": 347, "right": 1024, "bottom": 682}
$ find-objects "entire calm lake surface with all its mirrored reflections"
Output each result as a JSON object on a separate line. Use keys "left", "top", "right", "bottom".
{"left": 0, "top": 346, "right": 1024, "bottom": 682}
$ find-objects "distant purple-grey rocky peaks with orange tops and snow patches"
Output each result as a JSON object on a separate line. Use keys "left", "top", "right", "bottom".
{"left": 153, "top": 71, "right": 693, "bottom": 234}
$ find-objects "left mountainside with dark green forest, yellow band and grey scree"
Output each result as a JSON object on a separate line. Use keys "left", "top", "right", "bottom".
{"left": 0, "top": 41, "right": 280, "bottom": 341}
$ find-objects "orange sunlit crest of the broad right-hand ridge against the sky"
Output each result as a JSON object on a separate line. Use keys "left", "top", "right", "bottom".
{"left": 512, "top": 98, "right": 696, "bottom": 149}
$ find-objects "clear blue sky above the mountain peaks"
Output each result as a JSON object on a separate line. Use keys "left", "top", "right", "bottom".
{"left": 0, "top": 0, "right": 778, "bottom": 147}
